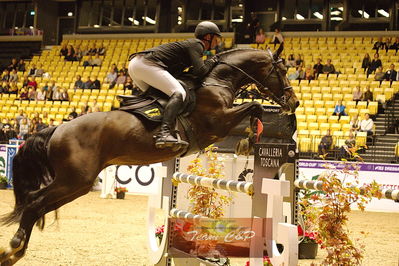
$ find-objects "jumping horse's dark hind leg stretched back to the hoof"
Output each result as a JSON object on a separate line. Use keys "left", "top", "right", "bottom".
{"left": 0, "top": 171, "right": 94, "bottom": 266}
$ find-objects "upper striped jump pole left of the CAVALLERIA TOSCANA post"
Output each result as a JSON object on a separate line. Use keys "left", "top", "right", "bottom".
{"left": 172, "top": 172, "right": 254, "bottom": 195}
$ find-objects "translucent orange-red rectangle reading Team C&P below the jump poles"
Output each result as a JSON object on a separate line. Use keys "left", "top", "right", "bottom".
{"left": 168, "top": 218, "right": 272, "bottom": 258}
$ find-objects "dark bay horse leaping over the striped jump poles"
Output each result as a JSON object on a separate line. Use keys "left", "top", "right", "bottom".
{"left": 0, "top": 46, "right": 299, "bottom": 266}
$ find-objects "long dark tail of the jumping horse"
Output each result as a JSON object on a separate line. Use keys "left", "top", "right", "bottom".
{"left": 0, "top": 127, "right": 56, "bottom": 224}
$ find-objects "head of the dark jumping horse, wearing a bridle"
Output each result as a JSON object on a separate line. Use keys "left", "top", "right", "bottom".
{"left": 257, "top": 44, "right": 299, "bottom": 113}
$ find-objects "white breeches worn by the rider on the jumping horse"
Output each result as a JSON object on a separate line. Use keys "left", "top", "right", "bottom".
{"left": 128, "top": 54, "right": 186, "bottom": 100}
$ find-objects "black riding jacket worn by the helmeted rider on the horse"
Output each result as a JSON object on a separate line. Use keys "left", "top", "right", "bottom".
{"left": 133, "top": 39, "right": 217, "bottom": 79}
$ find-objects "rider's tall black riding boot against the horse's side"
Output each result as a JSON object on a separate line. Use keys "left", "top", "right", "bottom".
{"left": 155, "top": 93, "right": 188, "bottom": 149}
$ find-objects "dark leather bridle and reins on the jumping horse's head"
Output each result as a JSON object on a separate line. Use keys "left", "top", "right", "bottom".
{"left": 219, "top": 50, "right": 292, "bottom": 107}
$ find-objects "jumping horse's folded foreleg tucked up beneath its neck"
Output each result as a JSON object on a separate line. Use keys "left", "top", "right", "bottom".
{"left": 220, "top": 102, "right": 263, "bottom": 137}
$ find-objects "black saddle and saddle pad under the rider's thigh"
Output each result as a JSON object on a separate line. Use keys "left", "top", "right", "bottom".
{"left": 117, "top": 80, "right": 198, "bottom": 123}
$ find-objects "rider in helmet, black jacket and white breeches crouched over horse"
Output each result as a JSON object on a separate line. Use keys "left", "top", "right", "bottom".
{"left": 129, "top": 21, "right": 221, "bottom": 148}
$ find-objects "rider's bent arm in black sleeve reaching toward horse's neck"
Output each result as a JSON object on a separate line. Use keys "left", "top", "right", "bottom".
{"left": 188, "top": 42, "right": 218, "bottom": 79}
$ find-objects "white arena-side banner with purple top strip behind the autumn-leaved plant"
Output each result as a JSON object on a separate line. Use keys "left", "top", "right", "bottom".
{"left": 298, "top": 160, "right": 399, "bottom": 212}
